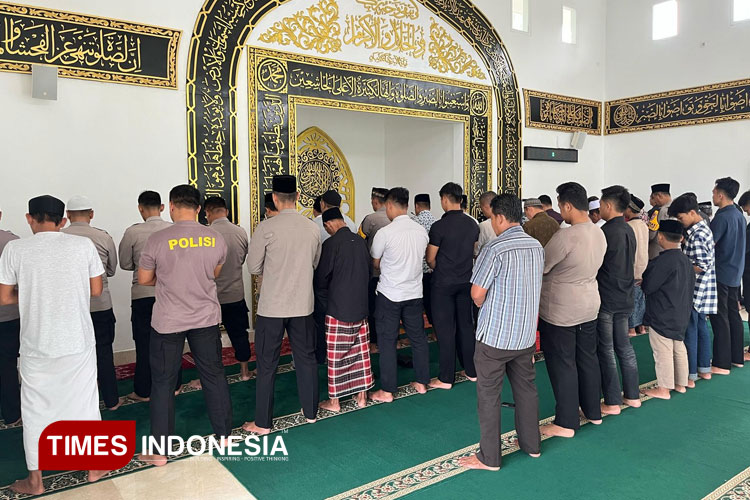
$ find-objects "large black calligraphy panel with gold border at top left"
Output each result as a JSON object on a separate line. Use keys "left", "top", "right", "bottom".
{"left": 0, "top": 3, "right": 181, "bottom": 88}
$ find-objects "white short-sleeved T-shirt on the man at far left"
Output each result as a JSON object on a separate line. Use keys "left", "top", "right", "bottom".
{"left": 0, "top": 232, "right": 104, "bottom": 358}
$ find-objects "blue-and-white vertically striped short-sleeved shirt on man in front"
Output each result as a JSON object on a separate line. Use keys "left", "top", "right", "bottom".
{"left": 471, "top": 226, "right": 544, "bottom": 351}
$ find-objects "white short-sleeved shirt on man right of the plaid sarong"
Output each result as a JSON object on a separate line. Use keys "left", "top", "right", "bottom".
{"left": 370, "top": 215, "right": 429, "bottom": 302}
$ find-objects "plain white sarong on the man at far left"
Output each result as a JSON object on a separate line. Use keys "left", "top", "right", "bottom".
{"left": 19, "top": 346, "right": 102, "bottom": 471}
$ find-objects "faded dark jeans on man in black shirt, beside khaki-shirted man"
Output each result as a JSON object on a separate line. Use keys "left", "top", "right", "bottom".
{"left": 597, "top": 311, "right": 640, "bottom": 405}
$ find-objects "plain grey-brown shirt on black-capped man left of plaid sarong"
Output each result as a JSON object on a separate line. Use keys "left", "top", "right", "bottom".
{"left": 247, "top": 209, "right": 320, "bottom": 318}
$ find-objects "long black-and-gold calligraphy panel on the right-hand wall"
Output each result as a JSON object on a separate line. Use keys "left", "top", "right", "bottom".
{"left": 606, "top": 80, "right": 750, "bottom": 134}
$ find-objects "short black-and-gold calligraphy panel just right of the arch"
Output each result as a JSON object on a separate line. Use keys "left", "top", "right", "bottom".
{"left": 523, "top": 89, "right": 602, "bottom": 135}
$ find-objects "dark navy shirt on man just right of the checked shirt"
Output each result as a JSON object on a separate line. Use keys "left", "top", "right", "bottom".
{"left": 711, "top": 205, "right": 745, "bottom": 287}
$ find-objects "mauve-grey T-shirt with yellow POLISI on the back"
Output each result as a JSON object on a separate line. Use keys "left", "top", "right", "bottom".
{"left": 138, "top": 221, "right": 227, "bottom": 333}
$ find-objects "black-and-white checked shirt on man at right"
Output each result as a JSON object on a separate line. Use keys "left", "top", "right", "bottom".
{"left": 684, "top": 220, "right": 719, "bottom": 314}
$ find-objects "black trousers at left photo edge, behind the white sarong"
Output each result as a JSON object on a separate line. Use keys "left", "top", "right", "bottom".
{"left": 0, "top": 319, "right": 21, "bottom": 424}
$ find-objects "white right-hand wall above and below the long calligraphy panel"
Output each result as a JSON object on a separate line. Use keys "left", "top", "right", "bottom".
{"left": 603, "top": 0, "right": 750, "bottom": 201}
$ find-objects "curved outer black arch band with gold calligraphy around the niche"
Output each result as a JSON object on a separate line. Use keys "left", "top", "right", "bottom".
{"left": 186, "top": 0, "right": 521, "bottom": 221}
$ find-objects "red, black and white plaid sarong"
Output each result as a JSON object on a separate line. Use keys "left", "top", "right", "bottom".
{"left": 326, "top": 316, "right": 374, "bottom": 398}
